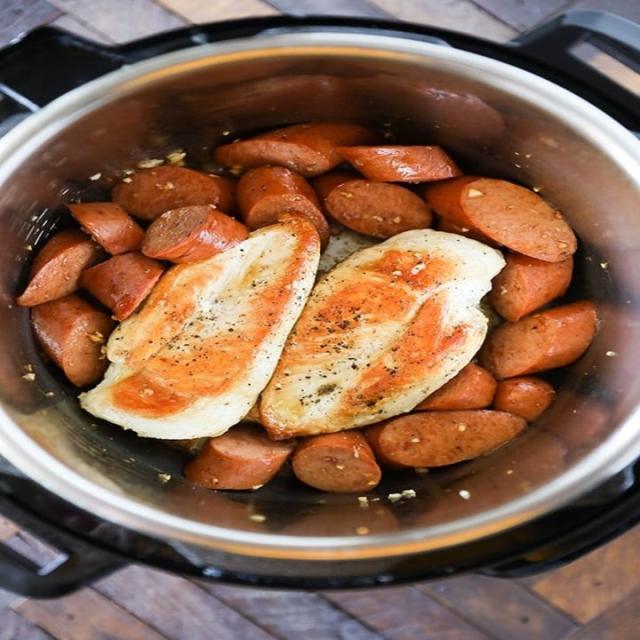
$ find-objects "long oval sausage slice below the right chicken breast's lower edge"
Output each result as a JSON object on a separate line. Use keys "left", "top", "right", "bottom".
{"left": 365, "top": 409, "right": 527, "bottom": 467}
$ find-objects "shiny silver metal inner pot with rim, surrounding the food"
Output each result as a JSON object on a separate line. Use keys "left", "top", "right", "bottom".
{"left": 0, "top": 33, "right": 640, "bottom": 567}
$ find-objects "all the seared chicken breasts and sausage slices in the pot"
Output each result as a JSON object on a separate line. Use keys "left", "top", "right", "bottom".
{"left": 17, "top": 123, "right": 597, "bottom": 498}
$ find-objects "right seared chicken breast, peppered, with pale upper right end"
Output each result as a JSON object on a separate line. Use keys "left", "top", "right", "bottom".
{"left": 260, "top": 229, "right": 504, "bottom": 439}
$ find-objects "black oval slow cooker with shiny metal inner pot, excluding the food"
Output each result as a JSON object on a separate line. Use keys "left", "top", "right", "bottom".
{"left": 0, "top": 13, "right": 640, "bottom": 596}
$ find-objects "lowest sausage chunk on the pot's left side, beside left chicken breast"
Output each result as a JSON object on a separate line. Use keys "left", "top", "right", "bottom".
{"left": 31, "top": 294, "right": 115, "bottom": 387}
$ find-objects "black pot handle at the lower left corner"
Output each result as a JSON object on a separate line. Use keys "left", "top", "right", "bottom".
{"left": 0, "top": 490, "right": 125, "bottom": 598}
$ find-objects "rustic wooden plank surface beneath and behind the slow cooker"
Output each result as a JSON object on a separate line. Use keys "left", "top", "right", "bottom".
{"left": 0, "top": 0, "right": 640, "bottom": 640}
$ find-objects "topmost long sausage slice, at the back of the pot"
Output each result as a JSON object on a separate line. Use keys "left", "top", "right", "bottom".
{"left": 213, "top": 122, "right": 376, "bottom": 177}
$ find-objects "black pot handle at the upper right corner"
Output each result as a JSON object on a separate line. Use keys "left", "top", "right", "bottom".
{"left": 511, "top": 11, "right": 640, "bottom": 124}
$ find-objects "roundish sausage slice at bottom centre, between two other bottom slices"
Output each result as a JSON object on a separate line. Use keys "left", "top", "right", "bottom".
{"left": 291, "top": 431, "right": 382, "bottom": 493}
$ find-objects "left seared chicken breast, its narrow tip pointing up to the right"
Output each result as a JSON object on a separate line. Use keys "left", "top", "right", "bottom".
{"left": 80, "top": 218, "right": 320, "bottom": 439}
